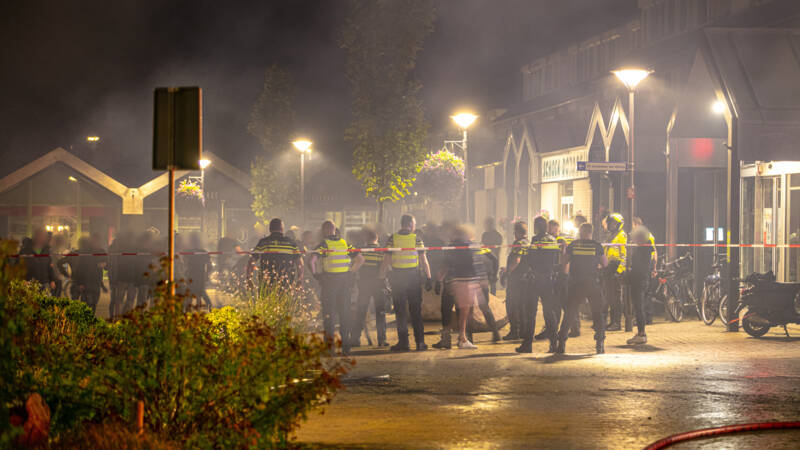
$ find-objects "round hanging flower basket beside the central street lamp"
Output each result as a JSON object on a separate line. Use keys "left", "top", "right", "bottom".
{"left": 414, "top": 149, "right": 464, "bottom": 204}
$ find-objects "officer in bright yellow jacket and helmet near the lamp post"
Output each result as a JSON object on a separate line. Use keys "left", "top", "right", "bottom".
{"left": 603, "top": 213, "right": 629, "bottom": 331}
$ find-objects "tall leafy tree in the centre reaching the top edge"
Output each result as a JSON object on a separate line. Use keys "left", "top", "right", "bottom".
{"left": 339, "top": 0, "right": 435, "bottom": 220}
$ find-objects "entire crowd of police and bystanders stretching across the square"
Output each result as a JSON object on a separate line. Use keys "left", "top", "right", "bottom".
{"left": 14, "top": 207, "right": 656, "bottom": 354}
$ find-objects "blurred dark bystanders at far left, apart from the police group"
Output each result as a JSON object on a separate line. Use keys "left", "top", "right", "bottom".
{"left": 18, "top": 229, "right": 219, "bottom": 318}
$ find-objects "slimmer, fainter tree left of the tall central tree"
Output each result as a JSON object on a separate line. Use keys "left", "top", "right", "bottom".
{"left": 247, "top": 65, "right": 300, "bottom": 223}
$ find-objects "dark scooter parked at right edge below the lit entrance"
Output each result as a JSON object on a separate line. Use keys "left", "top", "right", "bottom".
{"left": 736, "top": 271, "right": 800, "bottom": 337}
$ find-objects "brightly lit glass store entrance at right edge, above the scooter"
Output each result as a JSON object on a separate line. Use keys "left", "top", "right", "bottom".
{"left": 741, "top": 161, "right": 800, "bottom": 282}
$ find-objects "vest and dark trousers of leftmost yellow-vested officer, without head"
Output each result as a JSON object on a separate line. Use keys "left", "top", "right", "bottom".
{"left": 315, "top": 236, "right": 355, "bottom": 353}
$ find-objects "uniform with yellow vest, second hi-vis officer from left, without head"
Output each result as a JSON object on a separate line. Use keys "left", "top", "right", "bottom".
{"left": 386, "top": 230, "right": 425, "bottom": 350}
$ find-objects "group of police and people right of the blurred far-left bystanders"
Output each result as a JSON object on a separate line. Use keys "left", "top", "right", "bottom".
{"left": 250, "top": 209, "right": 656, "bottom": 354}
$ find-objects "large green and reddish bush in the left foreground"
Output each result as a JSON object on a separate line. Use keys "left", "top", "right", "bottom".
{"left": 0, "top": 246, "right": 349, "bottom": 448}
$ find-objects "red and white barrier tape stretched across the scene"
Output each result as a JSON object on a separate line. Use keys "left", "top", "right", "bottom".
{"left": 11, "top": 243, "right": 800, "bottom": 258}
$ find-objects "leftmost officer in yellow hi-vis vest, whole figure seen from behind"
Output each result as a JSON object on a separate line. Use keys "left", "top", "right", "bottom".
{"left": 310, "top": 220, "right": 364, "bottom": 355}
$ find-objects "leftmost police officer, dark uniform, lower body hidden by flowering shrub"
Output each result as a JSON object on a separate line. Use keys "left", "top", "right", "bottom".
{"left": 248, "top": 218, "right": 303, "bottom": 287}
